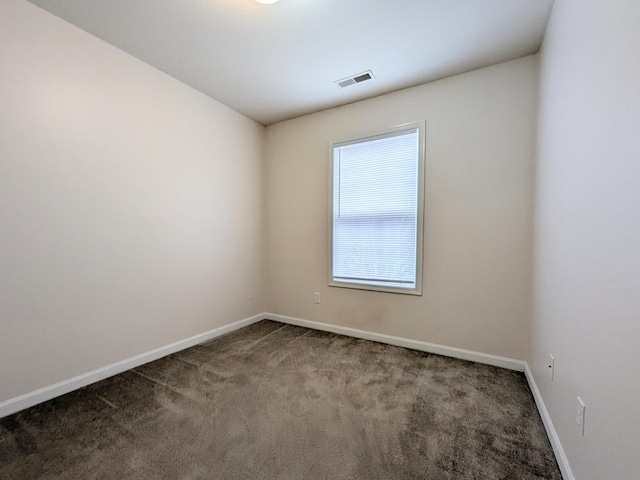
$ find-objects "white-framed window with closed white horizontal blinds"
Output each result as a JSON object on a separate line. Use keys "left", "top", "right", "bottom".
{"left": 329, "top": 124, "right": 424, "bottom": 295}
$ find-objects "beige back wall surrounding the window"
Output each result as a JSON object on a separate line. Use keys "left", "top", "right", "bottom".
{"left": 266, "top": 56, "right": 538, "bottom": 359}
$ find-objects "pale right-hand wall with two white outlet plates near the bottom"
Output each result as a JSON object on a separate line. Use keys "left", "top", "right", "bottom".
{"left": 529, "top": 0, "right": 640, "bottom": 480}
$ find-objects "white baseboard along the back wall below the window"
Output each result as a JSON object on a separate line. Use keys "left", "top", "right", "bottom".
{"left": 265, "top": 313, "right": 524, "bottom": 372}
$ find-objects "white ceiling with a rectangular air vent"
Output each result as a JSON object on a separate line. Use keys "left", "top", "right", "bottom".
{"left": 30, "top": 0, "right": 553, "bottom": 125}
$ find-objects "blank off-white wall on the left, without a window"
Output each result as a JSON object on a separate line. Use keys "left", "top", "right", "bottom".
{"left": 0, "top": 0, "right": 264, "bottom": 402}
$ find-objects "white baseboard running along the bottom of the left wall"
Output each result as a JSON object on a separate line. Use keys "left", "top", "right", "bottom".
{"left": 0, "top": 313, "right": 265, "bottom": 418}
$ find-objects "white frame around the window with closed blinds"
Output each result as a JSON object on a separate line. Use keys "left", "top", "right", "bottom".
{"left": 328, "top": 121, "right": 426, "bottom": 296}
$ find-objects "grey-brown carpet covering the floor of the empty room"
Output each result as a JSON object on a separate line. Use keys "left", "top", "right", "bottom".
{"left": 0, "top": 321, "right": 561, "bottom": 480}
